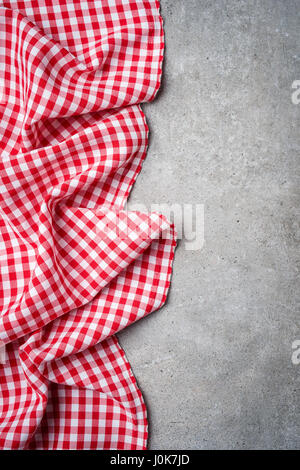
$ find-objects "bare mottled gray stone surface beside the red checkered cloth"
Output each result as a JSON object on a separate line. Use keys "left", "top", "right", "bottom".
{"left": 119, "top": 0, "right": 300, "bottom": 449}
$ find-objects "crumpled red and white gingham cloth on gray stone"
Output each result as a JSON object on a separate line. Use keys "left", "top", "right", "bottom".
{"left": 0, "top": 0, "right": 175, "bottom": 449}
